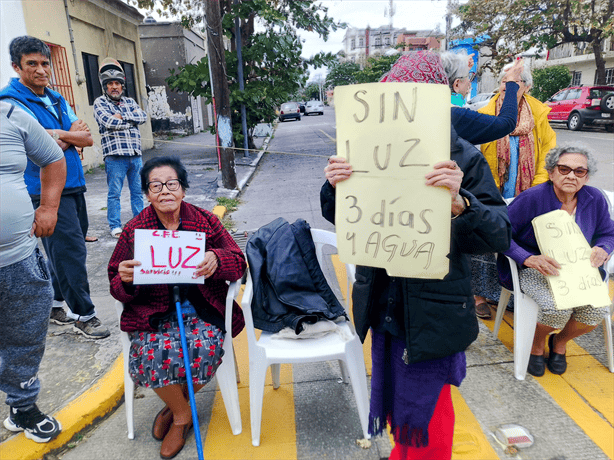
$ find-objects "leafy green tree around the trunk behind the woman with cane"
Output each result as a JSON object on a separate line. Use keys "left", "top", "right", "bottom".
{"left": 133, "top": 0, "right": 345, "bottom": 148}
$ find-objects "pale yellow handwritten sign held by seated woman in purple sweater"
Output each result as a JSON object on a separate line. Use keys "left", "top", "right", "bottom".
{"left": 533, "top": 210, "right": 612, "bottom": 310}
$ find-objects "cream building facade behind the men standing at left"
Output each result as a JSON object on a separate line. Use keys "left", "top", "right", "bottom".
{"left": 0, "top": 0, "right": 153, "bottom": 170}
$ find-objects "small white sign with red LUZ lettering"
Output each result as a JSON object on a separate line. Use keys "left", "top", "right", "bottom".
{"left": 134, "top": 229, "right": 205, "bottom": 284}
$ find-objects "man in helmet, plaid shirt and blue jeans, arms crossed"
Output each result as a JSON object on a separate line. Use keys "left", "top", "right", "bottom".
{"left": 94, "top": 58, "right": 147, "bottom": 238}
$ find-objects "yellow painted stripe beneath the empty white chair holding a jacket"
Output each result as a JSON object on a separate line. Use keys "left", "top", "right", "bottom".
{"left": 203, "top": 286, "right": 297, "bottom": 460}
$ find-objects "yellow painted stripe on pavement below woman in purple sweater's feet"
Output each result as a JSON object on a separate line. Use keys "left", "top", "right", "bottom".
{"left": 484, "top": 312, "right": 614, "bottom": 458}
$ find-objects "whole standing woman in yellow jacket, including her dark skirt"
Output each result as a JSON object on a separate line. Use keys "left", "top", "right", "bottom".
{"left": 471, "top": 60, "right": 556, "bottom": 319}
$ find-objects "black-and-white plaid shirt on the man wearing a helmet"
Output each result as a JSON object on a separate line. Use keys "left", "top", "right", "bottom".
{"left": 94, "top": 95, "right": 147, "bottom": 157}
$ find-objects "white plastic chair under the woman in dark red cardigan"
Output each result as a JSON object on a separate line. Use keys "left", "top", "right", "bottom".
{"left": 115, "top": 281, "right": 242, "bottom": 439}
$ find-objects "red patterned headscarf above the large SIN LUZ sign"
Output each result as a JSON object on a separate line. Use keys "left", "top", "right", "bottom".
{"left": 380, "top": 51, "right": 448, "bottom": 85}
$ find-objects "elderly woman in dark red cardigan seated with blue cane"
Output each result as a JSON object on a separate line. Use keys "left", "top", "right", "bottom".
{"left": 108, "top": 157, "right": 246, "bottom": 458}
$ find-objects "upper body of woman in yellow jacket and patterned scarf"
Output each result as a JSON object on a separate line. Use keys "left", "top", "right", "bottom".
{"left": 479, "top": 64, "right": 556, "bottom": 198}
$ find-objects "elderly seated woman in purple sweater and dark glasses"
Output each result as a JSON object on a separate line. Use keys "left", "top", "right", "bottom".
{"left": 498, "top": 145, "right": 614, "bottom": 377}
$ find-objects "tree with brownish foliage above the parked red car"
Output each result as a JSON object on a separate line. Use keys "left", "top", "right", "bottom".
{"left": 456, "top": 0, "right": 614, "bottom": 84}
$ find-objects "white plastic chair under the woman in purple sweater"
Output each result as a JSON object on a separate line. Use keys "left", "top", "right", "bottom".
{"left": 493, "top": 255, "right": 614, "bottom": 380}
